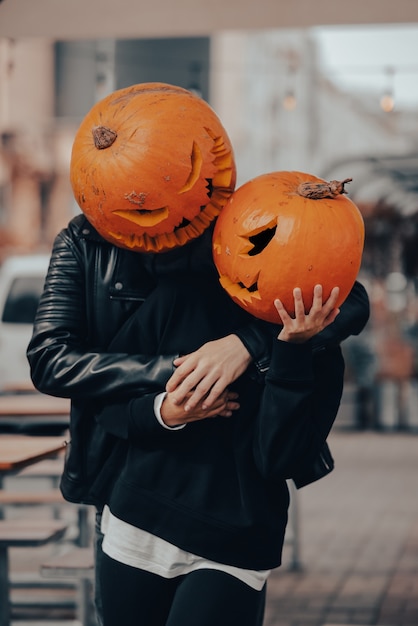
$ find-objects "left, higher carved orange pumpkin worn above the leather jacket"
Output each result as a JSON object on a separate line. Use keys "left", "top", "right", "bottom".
{"left": 70, "top": 83, "right": 236, "bottom": 252}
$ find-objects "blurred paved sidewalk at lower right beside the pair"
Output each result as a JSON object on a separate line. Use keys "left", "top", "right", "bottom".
{"left": 264, "top": 430, "right": 418, "bottom": 626}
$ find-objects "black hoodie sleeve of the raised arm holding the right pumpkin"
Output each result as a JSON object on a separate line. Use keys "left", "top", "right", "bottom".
{"left": 254, "top": 342, "right": 344, "bottom": 480}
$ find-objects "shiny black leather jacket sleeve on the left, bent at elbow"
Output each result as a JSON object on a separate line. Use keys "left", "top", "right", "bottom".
{"left": 27, "top": 230, "right": 177, "bottom": 399}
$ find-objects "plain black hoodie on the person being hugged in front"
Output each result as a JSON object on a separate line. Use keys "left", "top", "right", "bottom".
{"left": 96, "top": 230, "right": 344, "bottom": 569}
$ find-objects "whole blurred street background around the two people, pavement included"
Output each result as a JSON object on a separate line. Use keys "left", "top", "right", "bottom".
{"left": 0, "top": 0, "right": 418, "bottom": 626}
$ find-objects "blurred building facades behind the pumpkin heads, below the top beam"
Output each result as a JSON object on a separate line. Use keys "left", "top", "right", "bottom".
{"left": 0, "top": 29, "right": 418, "bottom": 249}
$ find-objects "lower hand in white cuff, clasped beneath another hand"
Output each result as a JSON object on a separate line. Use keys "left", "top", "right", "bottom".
{"left": 160, "top": 389, "right": 239, "bottom": 427}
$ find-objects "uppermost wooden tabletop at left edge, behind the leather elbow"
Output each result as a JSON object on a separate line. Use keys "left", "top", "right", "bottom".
{"left": 0, "top": 392, "right": 70, "bottom": 434}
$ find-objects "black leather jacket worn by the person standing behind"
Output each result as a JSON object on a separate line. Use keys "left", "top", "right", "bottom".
{"left": 27, "top": 215, "right": 369, "bottom": 506}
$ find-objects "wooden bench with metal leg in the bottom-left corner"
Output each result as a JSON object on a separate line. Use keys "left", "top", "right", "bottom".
{"left": 0, "top": 519, "right": 67, "bottom": 626}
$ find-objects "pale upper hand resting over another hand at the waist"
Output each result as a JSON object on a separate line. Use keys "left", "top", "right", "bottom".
{"left": 166, "top": 335, "right": 251, "bottom": 412}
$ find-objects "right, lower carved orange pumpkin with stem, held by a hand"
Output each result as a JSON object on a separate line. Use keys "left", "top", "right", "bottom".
{"left": 213, "top": 172, "right": 364, "bottom": 323}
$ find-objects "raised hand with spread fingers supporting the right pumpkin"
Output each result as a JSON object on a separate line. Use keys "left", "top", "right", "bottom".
{"left": 274, "top": 285, "right": 340, "bottom": 343}
